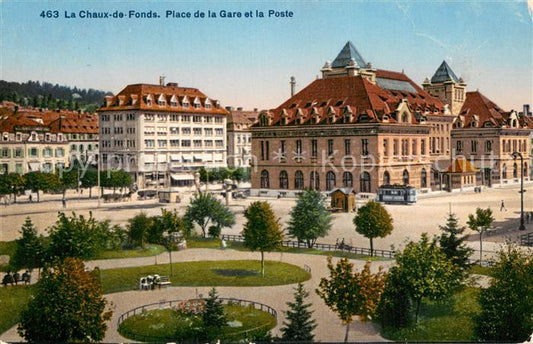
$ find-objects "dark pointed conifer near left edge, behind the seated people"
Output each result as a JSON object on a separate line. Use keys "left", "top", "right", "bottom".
{"left": 9, "top": 217, "right": 45, "bottom": 271}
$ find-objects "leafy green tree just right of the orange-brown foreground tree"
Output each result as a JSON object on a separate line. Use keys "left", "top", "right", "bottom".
{"left": 393, "top": 233, "right": 459, "bottom": 322}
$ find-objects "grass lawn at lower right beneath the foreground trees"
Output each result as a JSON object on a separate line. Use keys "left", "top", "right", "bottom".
{"left": 381, "top": 288, "right": 479, "bottom": 341}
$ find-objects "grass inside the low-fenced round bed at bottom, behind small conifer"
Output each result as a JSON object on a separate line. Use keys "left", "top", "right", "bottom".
{"left": 119, "top": 305, "right": 276, "bottom": 341}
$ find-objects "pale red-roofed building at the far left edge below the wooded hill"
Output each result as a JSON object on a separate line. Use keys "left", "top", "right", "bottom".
{"left": 0, "top": 113, "right": 69, "bottom": 174}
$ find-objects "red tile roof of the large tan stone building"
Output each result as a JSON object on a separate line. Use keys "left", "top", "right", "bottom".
{"left": 269, "top": 74, "right": 444, "bottom": 125}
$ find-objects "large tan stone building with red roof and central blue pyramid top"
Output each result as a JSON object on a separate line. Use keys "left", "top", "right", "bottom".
{"left": 252, "top": 42, "right": 442, "bottom": 195}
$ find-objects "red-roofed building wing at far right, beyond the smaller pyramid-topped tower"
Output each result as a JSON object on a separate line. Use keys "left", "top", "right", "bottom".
{"left": 451, "top": 91, "right": 533, "bottom": 186}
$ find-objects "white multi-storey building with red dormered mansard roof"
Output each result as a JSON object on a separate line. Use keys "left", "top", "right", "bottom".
{"left": 98, "top": 83, "right": 228, "bottom": 188}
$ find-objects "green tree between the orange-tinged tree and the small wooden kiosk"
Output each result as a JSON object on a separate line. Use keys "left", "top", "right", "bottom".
{"left": 287, "top": 189, "right": 331, "bottom": 248}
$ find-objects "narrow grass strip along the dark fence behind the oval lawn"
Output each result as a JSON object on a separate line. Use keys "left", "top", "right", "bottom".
{"left": 187, "top": 238, "right": 390, "bottom": 261}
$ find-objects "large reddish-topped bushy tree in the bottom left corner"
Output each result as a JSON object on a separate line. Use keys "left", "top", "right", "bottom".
{"left": 18, "top": 258, "right": 112, "bottom": 343}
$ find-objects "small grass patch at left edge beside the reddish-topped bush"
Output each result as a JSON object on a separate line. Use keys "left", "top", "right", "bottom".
{"left": 0, "top": 286, "right": 34, "bottom": 334}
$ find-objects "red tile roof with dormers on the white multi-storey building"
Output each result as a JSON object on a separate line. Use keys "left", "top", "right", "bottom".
{"left": 98, "top": 84, "right": 228, "bottom": 115}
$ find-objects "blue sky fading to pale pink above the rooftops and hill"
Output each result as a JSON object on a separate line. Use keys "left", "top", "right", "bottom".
{"left": 0, "top": 0, "right": 533, "bottom": 110}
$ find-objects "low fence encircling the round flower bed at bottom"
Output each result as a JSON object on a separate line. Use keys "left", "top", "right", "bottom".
{"left": 117, "top": 297, "right": 278, "bottom": 342}
